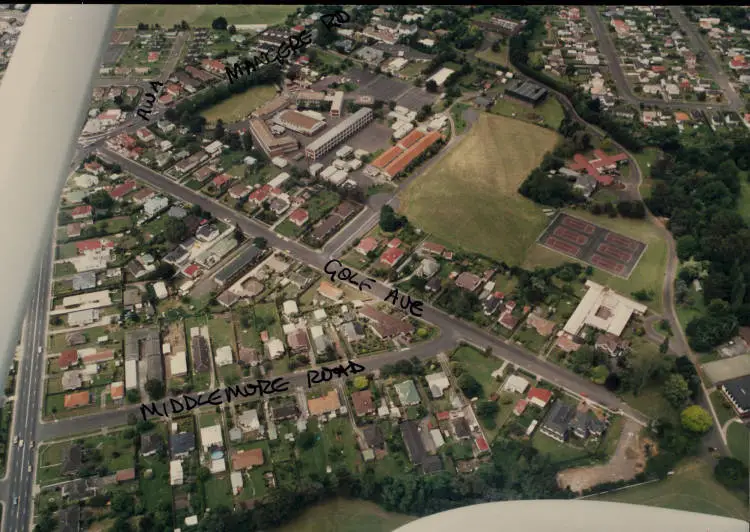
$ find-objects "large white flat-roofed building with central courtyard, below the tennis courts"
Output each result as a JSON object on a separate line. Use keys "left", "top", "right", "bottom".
{"left": 563, "top": 280, "right": 648, "bottom": 336}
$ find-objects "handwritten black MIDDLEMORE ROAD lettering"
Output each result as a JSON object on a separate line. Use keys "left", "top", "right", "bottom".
{"left": 141, "top": 361, "right": 365, "bottom": 420}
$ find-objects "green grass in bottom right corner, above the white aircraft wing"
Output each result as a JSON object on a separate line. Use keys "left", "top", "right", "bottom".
{"left": 590, "top": 460, "right": 748, "bottom": 520}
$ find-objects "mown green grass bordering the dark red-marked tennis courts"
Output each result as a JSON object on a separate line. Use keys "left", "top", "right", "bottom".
{"left": 524, "top": 209, "right": 667, "bottom": 312}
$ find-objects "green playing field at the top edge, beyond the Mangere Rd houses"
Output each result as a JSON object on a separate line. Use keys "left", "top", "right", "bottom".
{"left": 116, "top": 4, "right": 300, "bottom": 27}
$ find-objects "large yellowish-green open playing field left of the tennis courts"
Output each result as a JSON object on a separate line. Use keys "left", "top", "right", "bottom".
{"left": 400, "top": 113, "right": 559, "bottom": 265}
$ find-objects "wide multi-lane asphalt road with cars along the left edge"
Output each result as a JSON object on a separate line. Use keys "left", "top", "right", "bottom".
{"left": 0, "top": 243, "right": 52, "bottom": 531}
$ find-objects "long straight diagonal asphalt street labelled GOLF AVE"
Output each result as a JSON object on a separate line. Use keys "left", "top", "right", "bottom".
{"left": 98, "top": 150, "right": 646, "bottom": 423}
